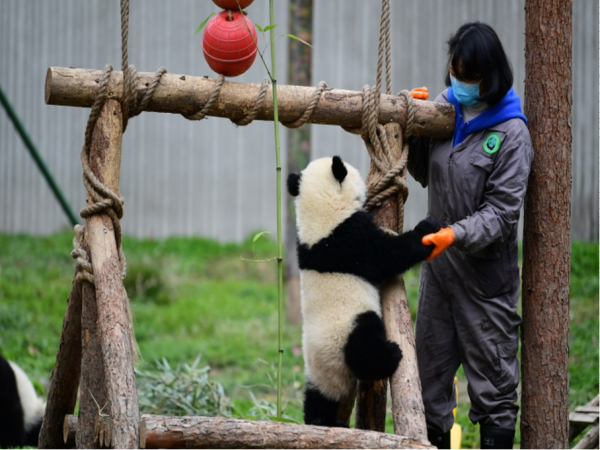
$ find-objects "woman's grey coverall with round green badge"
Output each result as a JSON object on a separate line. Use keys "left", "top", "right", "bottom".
{"left": 408, "top": 91, "right": 533, "bottom": 433}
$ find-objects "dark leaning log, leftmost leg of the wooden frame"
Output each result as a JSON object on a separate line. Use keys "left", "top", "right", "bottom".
{"left": 38, "top": 280, "right": 82, "bottom": 450}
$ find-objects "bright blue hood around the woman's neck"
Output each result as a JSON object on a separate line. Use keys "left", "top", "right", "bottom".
{"left": 448, "top": 87, "right": 527, "bottom": 146}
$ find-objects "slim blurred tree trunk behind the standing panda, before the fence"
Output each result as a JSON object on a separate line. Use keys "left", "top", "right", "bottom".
{"left": 285, "top": 0, "right": 312, "bottom": 325}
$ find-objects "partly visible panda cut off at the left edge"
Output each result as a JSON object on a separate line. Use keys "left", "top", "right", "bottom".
{"left": 0, "top": 355, "right": 46, "bottom": 448}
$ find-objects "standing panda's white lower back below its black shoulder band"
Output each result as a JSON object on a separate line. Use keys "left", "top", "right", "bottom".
{"left": 300, "top": 270, "right": 381, "bottom": 400}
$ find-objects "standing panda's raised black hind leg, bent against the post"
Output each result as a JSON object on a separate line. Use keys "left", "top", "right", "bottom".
{"left": 344, "top": 311, "right": 402, "bottom": 381}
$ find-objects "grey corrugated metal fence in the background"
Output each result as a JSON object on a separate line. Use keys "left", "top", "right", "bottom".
{"left": 0, "top": 0, "right": 600, "bottom": 241}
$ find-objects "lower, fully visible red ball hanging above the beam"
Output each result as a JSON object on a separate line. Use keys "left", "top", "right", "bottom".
{"left": 202, "top": 10, "right": 258, "bottom": 77}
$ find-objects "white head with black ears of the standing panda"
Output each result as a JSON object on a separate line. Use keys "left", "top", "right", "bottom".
{"left": 287, "top": 156, "right": 367, "bottom": 246}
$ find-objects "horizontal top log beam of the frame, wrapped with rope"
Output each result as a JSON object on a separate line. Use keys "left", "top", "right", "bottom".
{"left": 45, "top": 67, "right": 454, "bottom": 139}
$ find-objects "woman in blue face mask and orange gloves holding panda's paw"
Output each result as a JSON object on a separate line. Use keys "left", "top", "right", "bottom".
{"left": 408, "top": 22, "right": 533, "bottom": 449}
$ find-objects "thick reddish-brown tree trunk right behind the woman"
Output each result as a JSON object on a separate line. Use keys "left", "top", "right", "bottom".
{"left": 521, "top": 0, "right": 572, "bottom": 449}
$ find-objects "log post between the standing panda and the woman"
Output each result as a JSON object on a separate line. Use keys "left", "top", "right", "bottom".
{"left": 357, "top": 124, "right": 427, "bottom": 441}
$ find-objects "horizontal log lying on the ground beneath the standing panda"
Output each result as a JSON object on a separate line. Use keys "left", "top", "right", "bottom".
{"left": 64, "top": 414, "right": 434, "bottom": 450}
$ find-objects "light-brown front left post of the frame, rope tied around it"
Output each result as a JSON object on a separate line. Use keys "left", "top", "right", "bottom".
{"left": 85, "top": 100, "right": 139, "bottom": 449}
